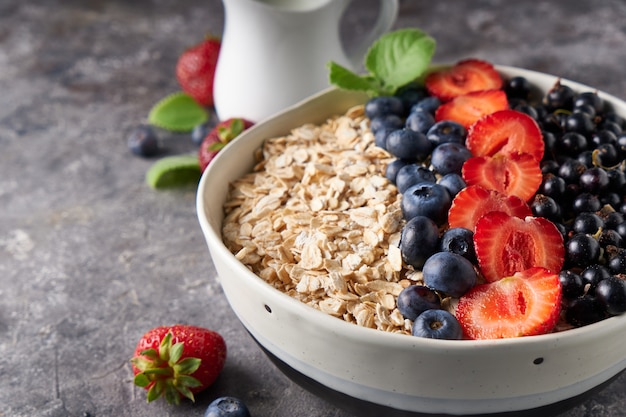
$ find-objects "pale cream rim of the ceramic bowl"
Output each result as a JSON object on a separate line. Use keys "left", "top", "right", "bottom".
{"left": 196, "top": 61, "right": 626, "bottom": 351}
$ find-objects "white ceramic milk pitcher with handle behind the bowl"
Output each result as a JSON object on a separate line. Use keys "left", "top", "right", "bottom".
{"left": 213, "top": 0, "right": 398, "bottom": 122}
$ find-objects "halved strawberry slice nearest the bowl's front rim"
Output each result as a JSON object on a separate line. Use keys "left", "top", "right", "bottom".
{"left": 456, "top": 267, "right": 562, "bottom": 339}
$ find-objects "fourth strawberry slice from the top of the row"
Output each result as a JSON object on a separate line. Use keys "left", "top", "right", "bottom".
{"left": 462, "top": 153, "right": 543, "bottom": 202}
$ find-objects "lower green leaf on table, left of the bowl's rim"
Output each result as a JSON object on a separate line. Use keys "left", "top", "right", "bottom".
{"left": 146, "top": 155, "right": 202, "bottom": 190}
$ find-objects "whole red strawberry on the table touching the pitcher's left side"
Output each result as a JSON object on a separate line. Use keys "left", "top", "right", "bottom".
{"left": 176, "top": 37, "right": 221, "bottom": 106}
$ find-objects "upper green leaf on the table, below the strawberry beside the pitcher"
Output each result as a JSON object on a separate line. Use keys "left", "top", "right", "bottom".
{"left": 148, "top": 92, "right": 209, "bottom": 132}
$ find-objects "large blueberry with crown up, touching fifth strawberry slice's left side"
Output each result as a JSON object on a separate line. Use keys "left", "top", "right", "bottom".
{"left": 401, "top": 182, "right": 452, "bottom": 225}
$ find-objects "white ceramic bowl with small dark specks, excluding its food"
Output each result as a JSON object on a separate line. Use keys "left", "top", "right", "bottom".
{"left": 197, "top": 66, "right": 626, "bottom": 416}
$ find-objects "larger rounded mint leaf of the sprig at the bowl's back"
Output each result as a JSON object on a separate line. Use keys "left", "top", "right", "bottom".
{"left": 365, "top": 29, "right": 435, "bottom": 94}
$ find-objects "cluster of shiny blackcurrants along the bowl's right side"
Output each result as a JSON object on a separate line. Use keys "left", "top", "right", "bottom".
{"left": 505, "top": 77, "right": 626, "bottom": 327}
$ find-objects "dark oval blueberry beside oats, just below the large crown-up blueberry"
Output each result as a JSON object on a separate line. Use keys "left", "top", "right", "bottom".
{"left": 400, "top": 216, "right": 439, "bottom": 269}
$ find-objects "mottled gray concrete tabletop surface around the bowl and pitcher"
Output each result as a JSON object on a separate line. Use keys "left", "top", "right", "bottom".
{"left": 0, "top": 0, "right": 626, "bottom": 417}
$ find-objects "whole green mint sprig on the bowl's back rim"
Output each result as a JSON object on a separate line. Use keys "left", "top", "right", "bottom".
{"left": 328, "top": 29, "right": 435, "bottom": 96}
